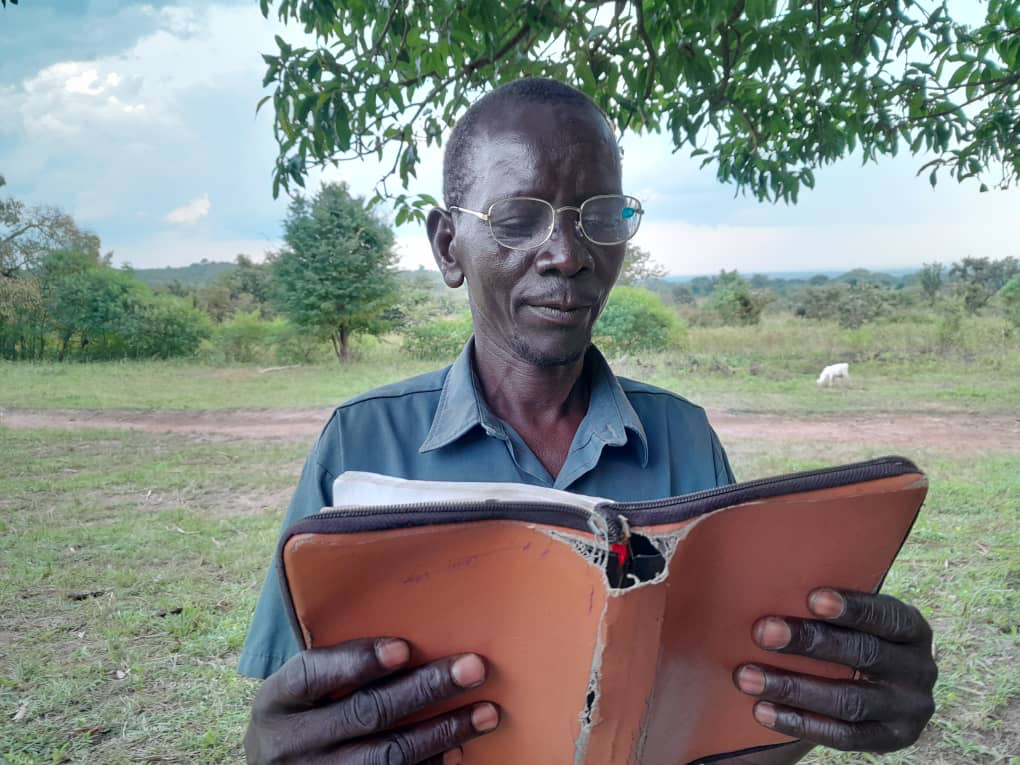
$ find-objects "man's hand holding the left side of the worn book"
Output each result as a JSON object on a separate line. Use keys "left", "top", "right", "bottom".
{"left": 245, "top": 638, "right": 499, "bottom": 765}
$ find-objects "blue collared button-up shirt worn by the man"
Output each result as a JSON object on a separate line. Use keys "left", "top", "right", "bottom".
{"left": 240, "top": 342, "right": 733, "bottom": 677}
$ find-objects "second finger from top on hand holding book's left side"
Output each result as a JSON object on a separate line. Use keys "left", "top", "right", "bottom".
{"left": 302, "top": 654, "right": 486, "bottom": 750}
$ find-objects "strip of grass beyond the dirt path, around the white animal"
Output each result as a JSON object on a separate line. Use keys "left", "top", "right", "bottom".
{"left": 0, "top": 319, "right": 1020, "bottom": 415}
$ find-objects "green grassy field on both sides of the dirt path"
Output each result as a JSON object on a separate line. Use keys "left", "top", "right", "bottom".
{"left": 0, "top": 324, "right": 1020, "bottom": 765}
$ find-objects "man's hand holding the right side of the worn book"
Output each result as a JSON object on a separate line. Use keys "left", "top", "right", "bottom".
{"left": 734, "top": 588, "right": 938, "bottom": 752}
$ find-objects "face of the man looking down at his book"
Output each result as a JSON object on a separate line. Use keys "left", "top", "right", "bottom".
{"left": 440, "top": 104, "right": 625, "bottom": 366}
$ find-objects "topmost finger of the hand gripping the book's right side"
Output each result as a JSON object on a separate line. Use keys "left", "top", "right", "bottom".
{"left": 808, "top": 588, "right": 931, "bottom": 644}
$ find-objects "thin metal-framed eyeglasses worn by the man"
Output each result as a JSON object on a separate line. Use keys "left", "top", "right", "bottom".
{"left": 450, "top": 194, "right": 645, "bottom": 250}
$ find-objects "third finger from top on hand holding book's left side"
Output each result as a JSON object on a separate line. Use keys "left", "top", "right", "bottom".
{"left": 325, "top": 702, "right": 499, "bottom": 765}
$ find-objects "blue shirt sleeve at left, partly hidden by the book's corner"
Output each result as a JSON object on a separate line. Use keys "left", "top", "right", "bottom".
{"left": 239, "top": 419, "right": 340, "bottom": 678}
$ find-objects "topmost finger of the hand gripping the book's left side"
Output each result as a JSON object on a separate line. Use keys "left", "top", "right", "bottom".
{"left": 271, "top": 638, "right": 410, "bottom": 709}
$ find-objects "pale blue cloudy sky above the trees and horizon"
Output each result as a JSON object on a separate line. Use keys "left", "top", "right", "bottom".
{"left": 0, "top": 0, "right": 1020, "bottom": 274}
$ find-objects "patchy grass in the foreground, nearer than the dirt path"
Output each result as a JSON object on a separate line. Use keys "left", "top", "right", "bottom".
{"left": 0, "top": 429, "right": 1020, "bottom": 765}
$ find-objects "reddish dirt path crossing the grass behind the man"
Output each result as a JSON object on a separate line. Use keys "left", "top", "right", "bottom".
{"left": 0, "top": 407, "right": 1020, "bottom": 452}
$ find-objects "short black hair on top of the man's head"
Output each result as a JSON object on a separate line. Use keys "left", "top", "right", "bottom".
{"left": 443, "top": 78, "right": 612, "bottom": 207}
